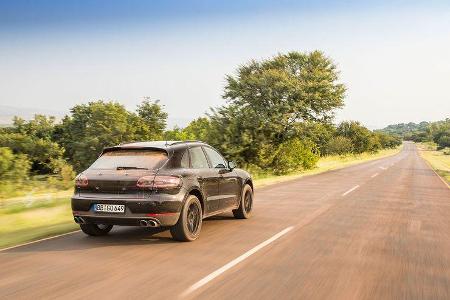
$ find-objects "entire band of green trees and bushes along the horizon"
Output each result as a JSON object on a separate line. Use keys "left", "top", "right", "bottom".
{"left": 0, "top": 51, "right": 408, "bottom": 188}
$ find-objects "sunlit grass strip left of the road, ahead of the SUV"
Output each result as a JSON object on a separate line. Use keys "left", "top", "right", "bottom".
{"left": 254, "top": 146, "right": 402, "bottom": 187}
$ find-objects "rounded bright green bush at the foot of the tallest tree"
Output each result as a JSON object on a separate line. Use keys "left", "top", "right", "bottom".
{"left": 272, "top": 139, "right": 319, "bottom": 175}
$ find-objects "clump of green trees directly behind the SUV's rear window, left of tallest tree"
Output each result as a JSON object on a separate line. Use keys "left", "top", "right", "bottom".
{"left": 59, "top": 101, "right": 167, "bottom": 171}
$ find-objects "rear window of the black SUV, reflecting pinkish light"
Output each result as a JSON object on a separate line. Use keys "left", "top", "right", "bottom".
{"left": 90, "top": 150, "right": 167, "bottom": 170}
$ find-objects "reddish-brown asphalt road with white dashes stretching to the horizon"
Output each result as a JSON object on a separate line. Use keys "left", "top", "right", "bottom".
{"left": 0, "top": 143, "right": 450, "bottom": 300}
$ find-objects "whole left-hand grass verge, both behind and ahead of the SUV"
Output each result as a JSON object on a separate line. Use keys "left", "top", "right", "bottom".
{"left": 0, "top": 147, "right": 400, "bottom": 249}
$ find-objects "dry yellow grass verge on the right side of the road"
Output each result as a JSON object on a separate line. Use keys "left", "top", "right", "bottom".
{"left": 418, "top": 143, "right": 450, "bottom": 183}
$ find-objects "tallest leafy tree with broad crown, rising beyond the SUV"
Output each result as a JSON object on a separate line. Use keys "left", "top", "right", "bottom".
{"left": 208, "top": 51, "right": 345, "bottom": 171}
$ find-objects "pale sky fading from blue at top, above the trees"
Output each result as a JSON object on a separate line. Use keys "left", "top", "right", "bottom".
{"left": 0, "top": 0, "right": 450, "bottom": 128}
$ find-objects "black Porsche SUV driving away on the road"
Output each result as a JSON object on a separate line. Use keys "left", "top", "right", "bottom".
{"left": 72, "top": 141, "right": 253, "bottom": 241}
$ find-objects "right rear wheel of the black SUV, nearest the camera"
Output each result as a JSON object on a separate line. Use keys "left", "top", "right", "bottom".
{"left": 170, "top": 195, "right": 203, "bottom": 242}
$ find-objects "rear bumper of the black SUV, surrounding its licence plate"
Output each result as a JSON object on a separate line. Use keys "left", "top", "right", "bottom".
{"left": 72, "top": 190, "right": 185, "bottom": 226}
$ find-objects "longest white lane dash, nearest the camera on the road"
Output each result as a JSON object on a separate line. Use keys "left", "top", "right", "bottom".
{"left": 181, "top": 226, "right": 294, "bottom": 297}
